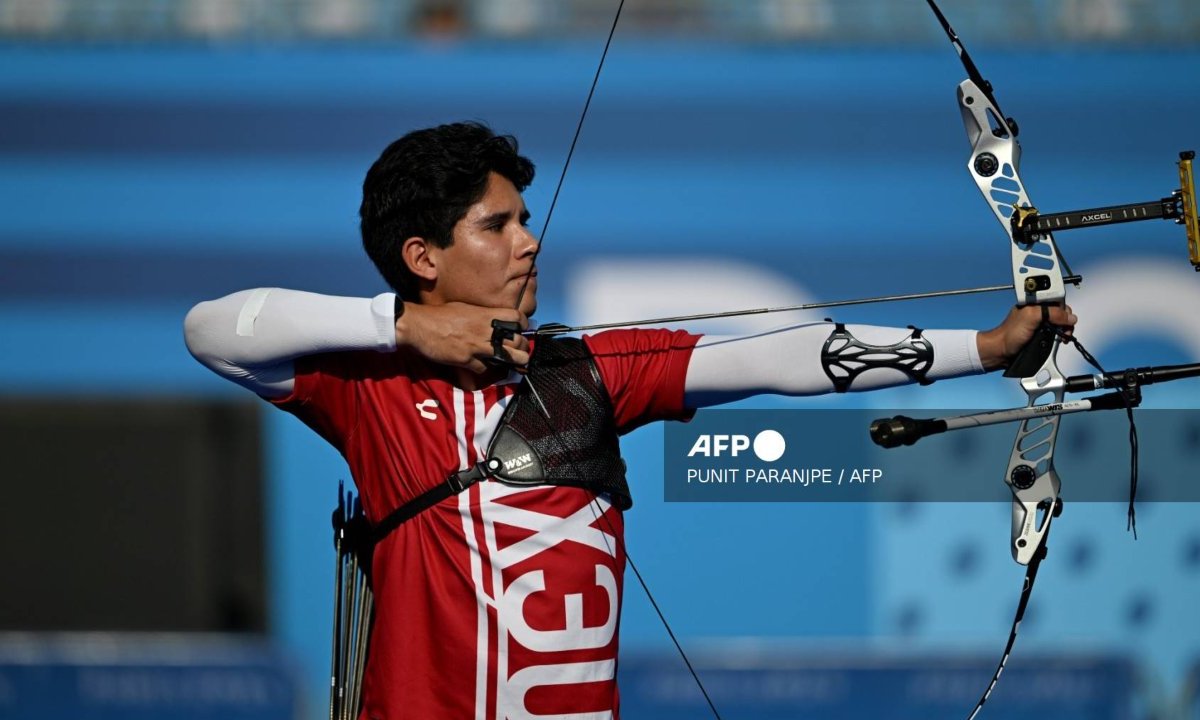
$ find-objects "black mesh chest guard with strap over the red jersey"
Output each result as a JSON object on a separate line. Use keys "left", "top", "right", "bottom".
{"left": 373, "top": 337, "right": 634, "bottom": 541}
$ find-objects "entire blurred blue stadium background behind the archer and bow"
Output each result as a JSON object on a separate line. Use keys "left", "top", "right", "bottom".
{"left": 0, "top": 0, "right": 1200, "bottom": 720}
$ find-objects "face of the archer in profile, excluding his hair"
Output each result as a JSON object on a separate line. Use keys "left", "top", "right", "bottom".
{"left": 430, "top": 173, "right": 538, "bottom": 316}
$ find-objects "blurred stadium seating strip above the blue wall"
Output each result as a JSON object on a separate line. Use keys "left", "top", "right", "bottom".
{"left": 0, "top": 0, "right": 1200, "bottom": 47}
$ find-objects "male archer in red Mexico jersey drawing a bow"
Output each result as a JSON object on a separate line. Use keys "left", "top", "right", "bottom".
{"left": 185, "top": 124, "right": 1075, "bottom": 720}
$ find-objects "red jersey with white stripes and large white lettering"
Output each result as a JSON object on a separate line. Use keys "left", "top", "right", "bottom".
{"left": 274, "top": 330, "right": 698, "bottom": 720}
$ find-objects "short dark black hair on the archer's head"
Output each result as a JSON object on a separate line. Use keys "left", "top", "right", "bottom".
{"left": 359, "top": 122, "right": 534, "bottom": 301}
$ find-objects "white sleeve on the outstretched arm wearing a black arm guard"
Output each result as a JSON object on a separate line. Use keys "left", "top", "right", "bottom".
{"left": 684, "top": 323, "right": 984, "bottom": 408}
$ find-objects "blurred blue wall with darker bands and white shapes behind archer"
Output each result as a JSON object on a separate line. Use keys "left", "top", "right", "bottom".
{"left": 0, "top": 42, "right": 1200, "bottom": 720}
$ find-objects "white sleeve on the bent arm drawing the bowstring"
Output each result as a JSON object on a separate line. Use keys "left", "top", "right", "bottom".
{"left": 184, "top": 288, "right": 396, "bottom": 397}
